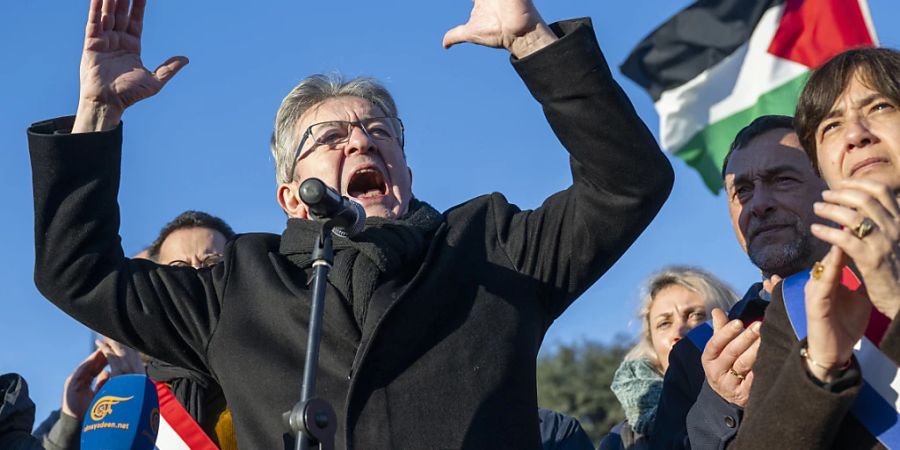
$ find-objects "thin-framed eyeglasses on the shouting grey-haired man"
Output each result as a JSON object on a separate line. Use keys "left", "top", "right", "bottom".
{"left": 290, "top": 117, "right": 403, "bottom": 177}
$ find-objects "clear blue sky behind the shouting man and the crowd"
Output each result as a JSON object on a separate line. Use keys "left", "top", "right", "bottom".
{"left": 0, "top": 0, "right": 900, "bottom": 420}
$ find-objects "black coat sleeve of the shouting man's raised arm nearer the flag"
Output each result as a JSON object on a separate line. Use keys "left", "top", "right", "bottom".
{"left": 494, "top": 19, "right": 673, "bottom": 318}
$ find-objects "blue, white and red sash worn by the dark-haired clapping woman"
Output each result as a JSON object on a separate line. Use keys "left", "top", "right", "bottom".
{"left": 781, "top": 267, "right": 900, "bottom": 448}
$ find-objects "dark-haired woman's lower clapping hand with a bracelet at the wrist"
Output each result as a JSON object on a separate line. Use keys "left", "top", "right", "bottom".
{"left": 805, "top": 246, "right": 872, "bottom": 382}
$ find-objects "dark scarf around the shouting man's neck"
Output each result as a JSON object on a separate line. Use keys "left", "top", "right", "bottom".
{"left": 281, "top": 199, "right": 443, "bottom": 328}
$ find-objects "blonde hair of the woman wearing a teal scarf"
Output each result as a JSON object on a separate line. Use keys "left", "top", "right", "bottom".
{"left": 625, "top": 266, "right": 739, "bottom": 374}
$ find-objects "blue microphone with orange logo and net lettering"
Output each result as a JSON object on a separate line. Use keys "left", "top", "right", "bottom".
{"left": 81, "top": 375, "right": 159, "bottom": 450}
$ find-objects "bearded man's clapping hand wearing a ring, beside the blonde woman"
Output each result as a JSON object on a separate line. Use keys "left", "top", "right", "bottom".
{"left": 700, "top": 308, "right": 761, "bottom": 407}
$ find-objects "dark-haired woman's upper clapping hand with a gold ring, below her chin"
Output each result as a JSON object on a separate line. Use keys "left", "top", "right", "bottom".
{"left": 812, "top": 179, "right": 900, "bottom": 319}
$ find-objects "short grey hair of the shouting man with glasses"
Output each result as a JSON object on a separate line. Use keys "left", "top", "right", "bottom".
{"left": 270, "top": 73, "right": 397, "bottom": 183}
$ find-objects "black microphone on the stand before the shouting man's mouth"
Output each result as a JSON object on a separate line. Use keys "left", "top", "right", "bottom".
{"left": 300, "top": 178, "right": 366, "bottom": 237}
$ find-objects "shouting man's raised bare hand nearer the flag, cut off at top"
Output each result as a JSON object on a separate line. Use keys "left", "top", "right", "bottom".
{"left": 443, "top": 0, "right": 556, "bottom": 58}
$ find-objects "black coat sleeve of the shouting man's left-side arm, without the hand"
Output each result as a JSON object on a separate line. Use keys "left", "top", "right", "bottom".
{"left": 28, "top": 118, "right": 227, "bottom": 370}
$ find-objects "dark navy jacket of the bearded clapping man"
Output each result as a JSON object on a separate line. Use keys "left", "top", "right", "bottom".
{"left": 650, "top": 283, "right": 769, "bottom": 449}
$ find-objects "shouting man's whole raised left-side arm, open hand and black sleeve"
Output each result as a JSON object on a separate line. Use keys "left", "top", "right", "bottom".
{"left": 28, "top": 0, "right": 224, "bottom": 370}
